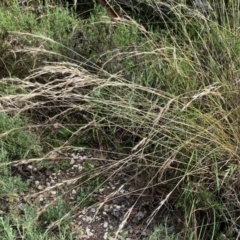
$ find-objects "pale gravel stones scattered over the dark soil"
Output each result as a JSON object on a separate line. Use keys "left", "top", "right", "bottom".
{"left": 11, "top": 149, "right": 174, "bottom": 240}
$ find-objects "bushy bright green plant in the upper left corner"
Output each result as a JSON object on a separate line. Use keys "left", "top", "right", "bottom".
{"left": 0, "top": 0, "right": 77, "bottom": 77}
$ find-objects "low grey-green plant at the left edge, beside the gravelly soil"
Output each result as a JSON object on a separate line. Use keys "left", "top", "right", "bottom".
{"left": 0, "top": 112, "right": 41, "bottom": 239}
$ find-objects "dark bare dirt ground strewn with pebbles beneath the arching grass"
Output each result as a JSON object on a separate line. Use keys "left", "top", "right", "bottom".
{"left": 8, "top": 149, "right": 182, "bottom": 240}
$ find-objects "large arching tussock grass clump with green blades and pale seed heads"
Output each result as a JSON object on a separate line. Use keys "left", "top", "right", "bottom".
{"left": 0, "top": 0, "right": 240, "bottom": 239}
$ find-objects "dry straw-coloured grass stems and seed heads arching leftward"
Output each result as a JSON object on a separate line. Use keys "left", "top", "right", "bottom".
{"left": 0, "top": 0, "right": 240, "bottom": 239}
